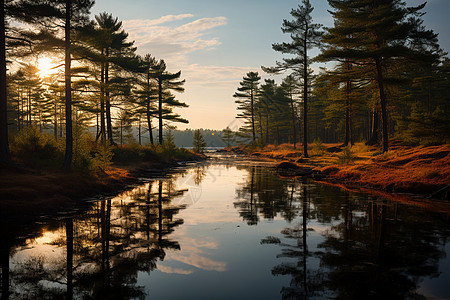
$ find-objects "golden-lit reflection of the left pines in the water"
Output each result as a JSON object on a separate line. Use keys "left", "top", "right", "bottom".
{"left": 1, "top": 180, "right": 184, "bottom": 299}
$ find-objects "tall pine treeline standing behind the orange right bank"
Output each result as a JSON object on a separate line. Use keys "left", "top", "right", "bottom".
{"left": 234, "top": 0, "right": 450, "bottom": 156}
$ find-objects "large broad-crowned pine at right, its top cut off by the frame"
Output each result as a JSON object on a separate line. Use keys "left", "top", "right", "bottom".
{"left": 320, "top": 0, "right": 437, "bottom": 152}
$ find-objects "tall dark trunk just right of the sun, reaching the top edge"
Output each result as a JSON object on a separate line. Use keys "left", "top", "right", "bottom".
{"left": 63, "top": 0, "right": 73, "bottom": 171}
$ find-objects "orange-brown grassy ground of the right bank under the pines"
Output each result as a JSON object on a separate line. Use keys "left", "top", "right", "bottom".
{"left": 230, "top": 141, "right": 450, "bottom": 200}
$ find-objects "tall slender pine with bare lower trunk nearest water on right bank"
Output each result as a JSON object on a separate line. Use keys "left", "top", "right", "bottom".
{"left": 262, "top": 0, "right": 322, "bottom": 157}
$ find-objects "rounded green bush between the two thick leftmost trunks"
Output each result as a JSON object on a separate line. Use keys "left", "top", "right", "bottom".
{"left": 11, "top": 126, "right": 62, "bottom": 167}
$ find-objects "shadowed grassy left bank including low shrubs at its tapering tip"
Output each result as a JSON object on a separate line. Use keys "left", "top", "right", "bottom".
{"left": 0, "top": 146, "right": 202, "bottom": 219}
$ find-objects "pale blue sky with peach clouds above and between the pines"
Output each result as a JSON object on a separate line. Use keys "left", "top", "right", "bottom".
{"left": 91, "top": 0, "right": 450, "bottom": 130}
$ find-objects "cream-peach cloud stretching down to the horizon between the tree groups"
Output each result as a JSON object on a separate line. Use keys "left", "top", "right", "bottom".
{"left": 123, "top": 14, "right": 260, "bottom": 128}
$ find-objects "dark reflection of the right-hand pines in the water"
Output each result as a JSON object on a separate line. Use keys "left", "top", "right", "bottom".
{"left": 235, "top": 167, "right": 449, "bottom": 299}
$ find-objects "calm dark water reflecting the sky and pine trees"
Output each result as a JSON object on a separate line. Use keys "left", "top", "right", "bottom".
{"left": 0, "top": 156, "right": 450, "bottom": 299}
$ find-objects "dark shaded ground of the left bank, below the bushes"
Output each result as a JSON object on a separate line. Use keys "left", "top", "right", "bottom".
{"left": 0, "top": 155, "right": 204, "bottom": 220}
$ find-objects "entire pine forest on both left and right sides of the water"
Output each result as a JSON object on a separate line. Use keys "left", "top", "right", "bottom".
{"left": 0, "top": 0, "right": 450, "bottom": 170}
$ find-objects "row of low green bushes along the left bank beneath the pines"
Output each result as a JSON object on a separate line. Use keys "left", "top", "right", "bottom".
{"left": 11, "top": 126, "right": 201, "bottom": 173}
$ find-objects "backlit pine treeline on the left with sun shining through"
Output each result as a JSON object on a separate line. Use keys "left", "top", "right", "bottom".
{"left": 0, "top": 0, "right": 188, "bottom": 170}
